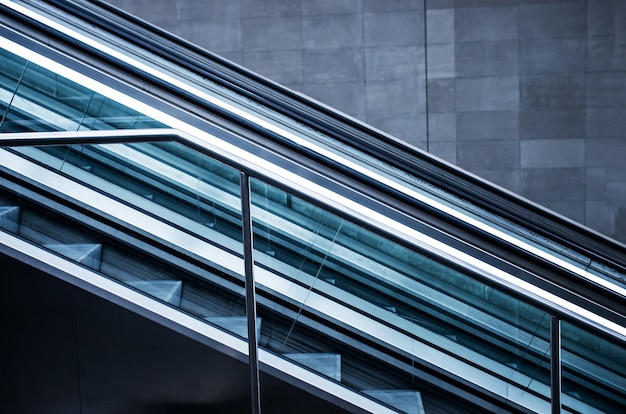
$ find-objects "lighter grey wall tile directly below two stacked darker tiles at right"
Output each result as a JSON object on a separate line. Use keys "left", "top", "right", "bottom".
{"left": 520, "top": 138, "right": 585, "bottom": 168}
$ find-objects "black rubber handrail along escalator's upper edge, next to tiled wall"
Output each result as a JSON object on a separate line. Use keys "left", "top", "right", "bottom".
{"left": 6, "top": 0, "right": 626, "bottom": 271}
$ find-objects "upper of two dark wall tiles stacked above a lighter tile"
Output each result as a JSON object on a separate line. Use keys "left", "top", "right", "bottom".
{"left": 520, "top": 75, "right": 586, "bottom": 110}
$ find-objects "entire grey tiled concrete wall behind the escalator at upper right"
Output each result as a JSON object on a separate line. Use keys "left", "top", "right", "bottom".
{"left": 110, "top": 0, "right": 626, "bottom": 241}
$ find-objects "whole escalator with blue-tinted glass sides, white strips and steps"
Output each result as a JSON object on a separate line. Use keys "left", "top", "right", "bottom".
{"left": 0, "top": 1, "right": 626, "bottom": 413}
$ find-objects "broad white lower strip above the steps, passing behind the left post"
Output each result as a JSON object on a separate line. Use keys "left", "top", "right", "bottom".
{"left": 0, "top": 149, "right": 612, "bottom": 412}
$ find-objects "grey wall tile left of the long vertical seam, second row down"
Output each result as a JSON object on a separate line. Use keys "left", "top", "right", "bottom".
{"left": 363, "top": 11, "right": 424, "bottom": 46}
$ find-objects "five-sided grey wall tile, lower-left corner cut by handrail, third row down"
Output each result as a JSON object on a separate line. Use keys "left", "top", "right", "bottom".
{"left": 243, "top": 50, "right": 303, "bottom": 84}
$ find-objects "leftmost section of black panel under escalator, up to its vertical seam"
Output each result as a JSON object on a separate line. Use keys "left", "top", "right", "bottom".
{"left": 0, "top": 255, "right": 80, "bottom": 414}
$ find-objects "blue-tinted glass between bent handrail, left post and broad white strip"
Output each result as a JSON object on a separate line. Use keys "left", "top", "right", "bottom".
{"left": 14, "top": 142, "right": 241, "bottom": 247}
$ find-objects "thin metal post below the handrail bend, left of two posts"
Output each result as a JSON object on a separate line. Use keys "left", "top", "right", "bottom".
{"left": 239, "top": 172, "right": 261, "bottom": 414}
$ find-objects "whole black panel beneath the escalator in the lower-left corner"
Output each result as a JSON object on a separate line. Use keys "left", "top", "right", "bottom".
{"left": 0, "top": 254, "right": 356, "bottom": 414}
